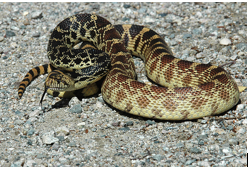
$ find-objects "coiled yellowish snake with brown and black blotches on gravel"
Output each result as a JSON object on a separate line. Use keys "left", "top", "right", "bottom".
{"left": 18, "top": 13, "right": 239, "bottom": 120}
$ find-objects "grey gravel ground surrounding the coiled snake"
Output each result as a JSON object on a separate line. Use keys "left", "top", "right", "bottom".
{"left": 0, "top": 2, "right": 247, "bottom": 167}
